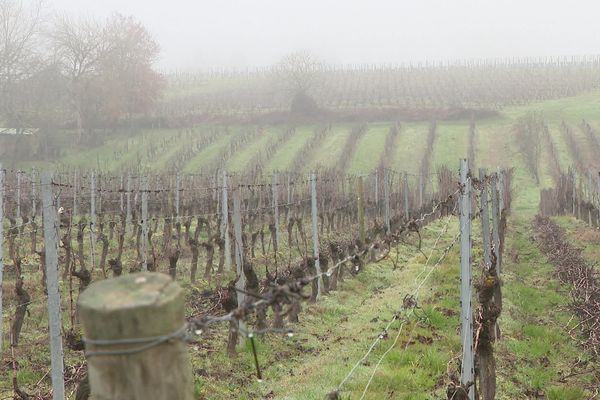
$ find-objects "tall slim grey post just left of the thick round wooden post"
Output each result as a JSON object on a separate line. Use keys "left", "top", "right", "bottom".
{"left": 42, "top": 172, "right": 65, "bottom": 400}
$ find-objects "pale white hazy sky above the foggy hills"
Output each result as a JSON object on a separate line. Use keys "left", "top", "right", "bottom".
{"left": 46, "top": 0, "right": 600, "bottom": 70}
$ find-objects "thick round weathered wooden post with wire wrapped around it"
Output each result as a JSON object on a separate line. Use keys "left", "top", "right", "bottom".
{"left": 78, "top": 272, "right": 194, "bottom": 400}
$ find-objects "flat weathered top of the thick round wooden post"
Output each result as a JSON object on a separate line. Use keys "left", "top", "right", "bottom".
{"left": 79, "top": 272, "right": 182, "bottom": 312}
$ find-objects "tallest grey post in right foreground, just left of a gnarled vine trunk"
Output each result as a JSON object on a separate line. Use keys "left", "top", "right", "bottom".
{"left": 460, "top": 159, "right": 475, "bottom": 400}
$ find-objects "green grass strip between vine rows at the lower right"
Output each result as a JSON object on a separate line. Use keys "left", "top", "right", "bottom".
{"left": 496, "top": 219, "right": 595, "bottom": 400}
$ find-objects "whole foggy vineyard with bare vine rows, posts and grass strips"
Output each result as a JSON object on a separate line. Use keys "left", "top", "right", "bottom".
{"left": 0, "top": 59, "right": 600, "bottom": 400}
